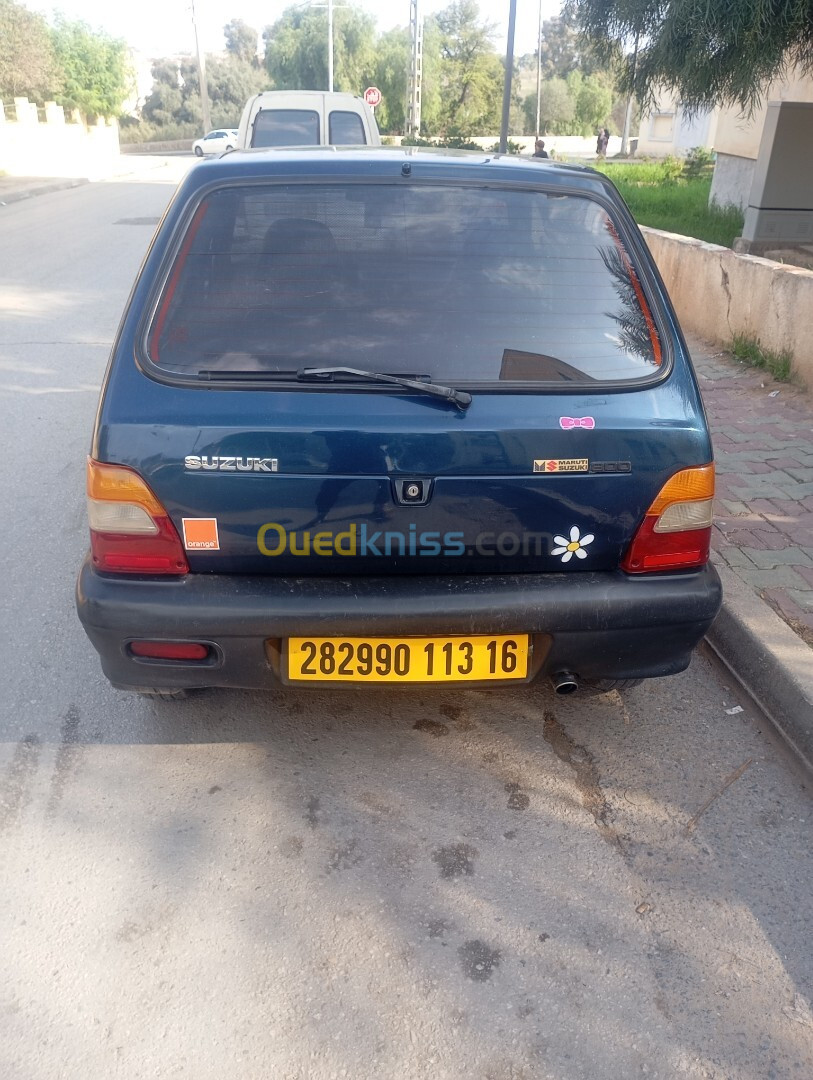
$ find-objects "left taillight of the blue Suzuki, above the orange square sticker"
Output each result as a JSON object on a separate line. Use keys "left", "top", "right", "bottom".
{"left": 87, "top": 458, "right": 189, "bottom": 575}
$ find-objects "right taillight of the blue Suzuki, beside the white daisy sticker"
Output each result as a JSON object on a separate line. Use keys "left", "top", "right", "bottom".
{"left": 621, "top": 464, "right": 714, "bottom": 573}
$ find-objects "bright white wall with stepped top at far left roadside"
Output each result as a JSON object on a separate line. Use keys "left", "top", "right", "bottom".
{"left": 0, "top": 97, "right": 119, "bottom": 179}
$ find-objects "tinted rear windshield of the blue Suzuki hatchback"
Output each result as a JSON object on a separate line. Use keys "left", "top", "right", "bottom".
{"left": 148, "top": 183, "right": 661, "bottom": 386}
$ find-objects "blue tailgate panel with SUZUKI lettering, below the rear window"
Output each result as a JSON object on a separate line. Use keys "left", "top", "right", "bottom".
{"left": 99, "top": 379, "right": 710, "bottom": 576}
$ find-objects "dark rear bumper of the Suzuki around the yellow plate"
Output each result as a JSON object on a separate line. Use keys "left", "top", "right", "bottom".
{"left": 77, "top": 562, "right": 721, "bottom": 689}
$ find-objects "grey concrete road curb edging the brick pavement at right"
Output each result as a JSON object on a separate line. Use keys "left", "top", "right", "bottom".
{"left": 706, "top": 562, "right": 813, "bottom": 768}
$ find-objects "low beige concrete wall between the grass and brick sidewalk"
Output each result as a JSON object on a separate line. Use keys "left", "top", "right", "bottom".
{"left": 641, "top": 228, "right": 813, "bottom": 390}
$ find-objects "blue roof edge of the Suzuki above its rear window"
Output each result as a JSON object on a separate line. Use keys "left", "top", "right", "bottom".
{"left": 182, "top": 146, "right": 614, "bottom": 194}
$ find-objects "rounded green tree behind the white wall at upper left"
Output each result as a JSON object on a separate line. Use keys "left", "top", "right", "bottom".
{"left": 52, "top": 16, "right": 133, "bottom": 118}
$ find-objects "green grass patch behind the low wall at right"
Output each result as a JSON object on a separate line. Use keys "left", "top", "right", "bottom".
{"left": 596, "top": 159, "right": 743, "bottom": 247}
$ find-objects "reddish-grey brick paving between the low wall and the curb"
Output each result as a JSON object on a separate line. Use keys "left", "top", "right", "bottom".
{"left": 689, "top": 338, "right": 813, "bottom": 646}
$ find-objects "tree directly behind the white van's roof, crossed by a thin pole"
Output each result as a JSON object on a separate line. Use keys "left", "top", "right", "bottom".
{"left": 262, "top": 6, "right": 376, "bottom": 94}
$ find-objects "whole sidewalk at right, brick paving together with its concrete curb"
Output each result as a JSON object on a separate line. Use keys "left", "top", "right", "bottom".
{"left": 689, "top": 338, "right": 813, "bottom": 769}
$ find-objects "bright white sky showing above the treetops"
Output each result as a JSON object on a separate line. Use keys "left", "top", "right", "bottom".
{"left": 33, "top": 0, "right": 561, "bottom": 57}
